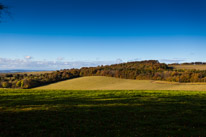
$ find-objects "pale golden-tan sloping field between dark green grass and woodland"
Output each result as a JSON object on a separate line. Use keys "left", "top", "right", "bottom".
{"left": 36, "top": 76, "right": 206, "bottom": 91}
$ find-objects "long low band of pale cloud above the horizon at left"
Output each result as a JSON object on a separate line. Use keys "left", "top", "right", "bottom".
{"left": 0, "top": 57, "right": 117, "bottom": 70}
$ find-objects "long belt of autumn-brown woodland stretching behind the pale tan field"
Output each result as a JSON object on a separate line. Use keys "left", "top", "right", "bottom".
{"left": 0, "top": 60, "right": 206, "bottom": 89}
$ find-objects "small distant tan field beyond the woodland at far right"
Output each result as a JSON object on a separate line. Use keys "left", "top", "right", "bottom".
{"left": 169, "top": 65, "right": 206, "bottom": 70}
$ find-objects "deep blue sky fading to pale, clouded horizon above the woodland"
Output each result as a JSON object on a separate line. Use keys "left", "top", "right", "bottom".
{"left": 0, "top": 0, "right": 206, "bottom": 70}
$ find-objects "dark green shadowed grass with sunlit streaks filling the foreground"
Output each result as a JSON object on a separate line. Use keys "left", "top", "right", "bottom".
{"left": 0, "top": 89, "right": 206, "bottom": 137}
